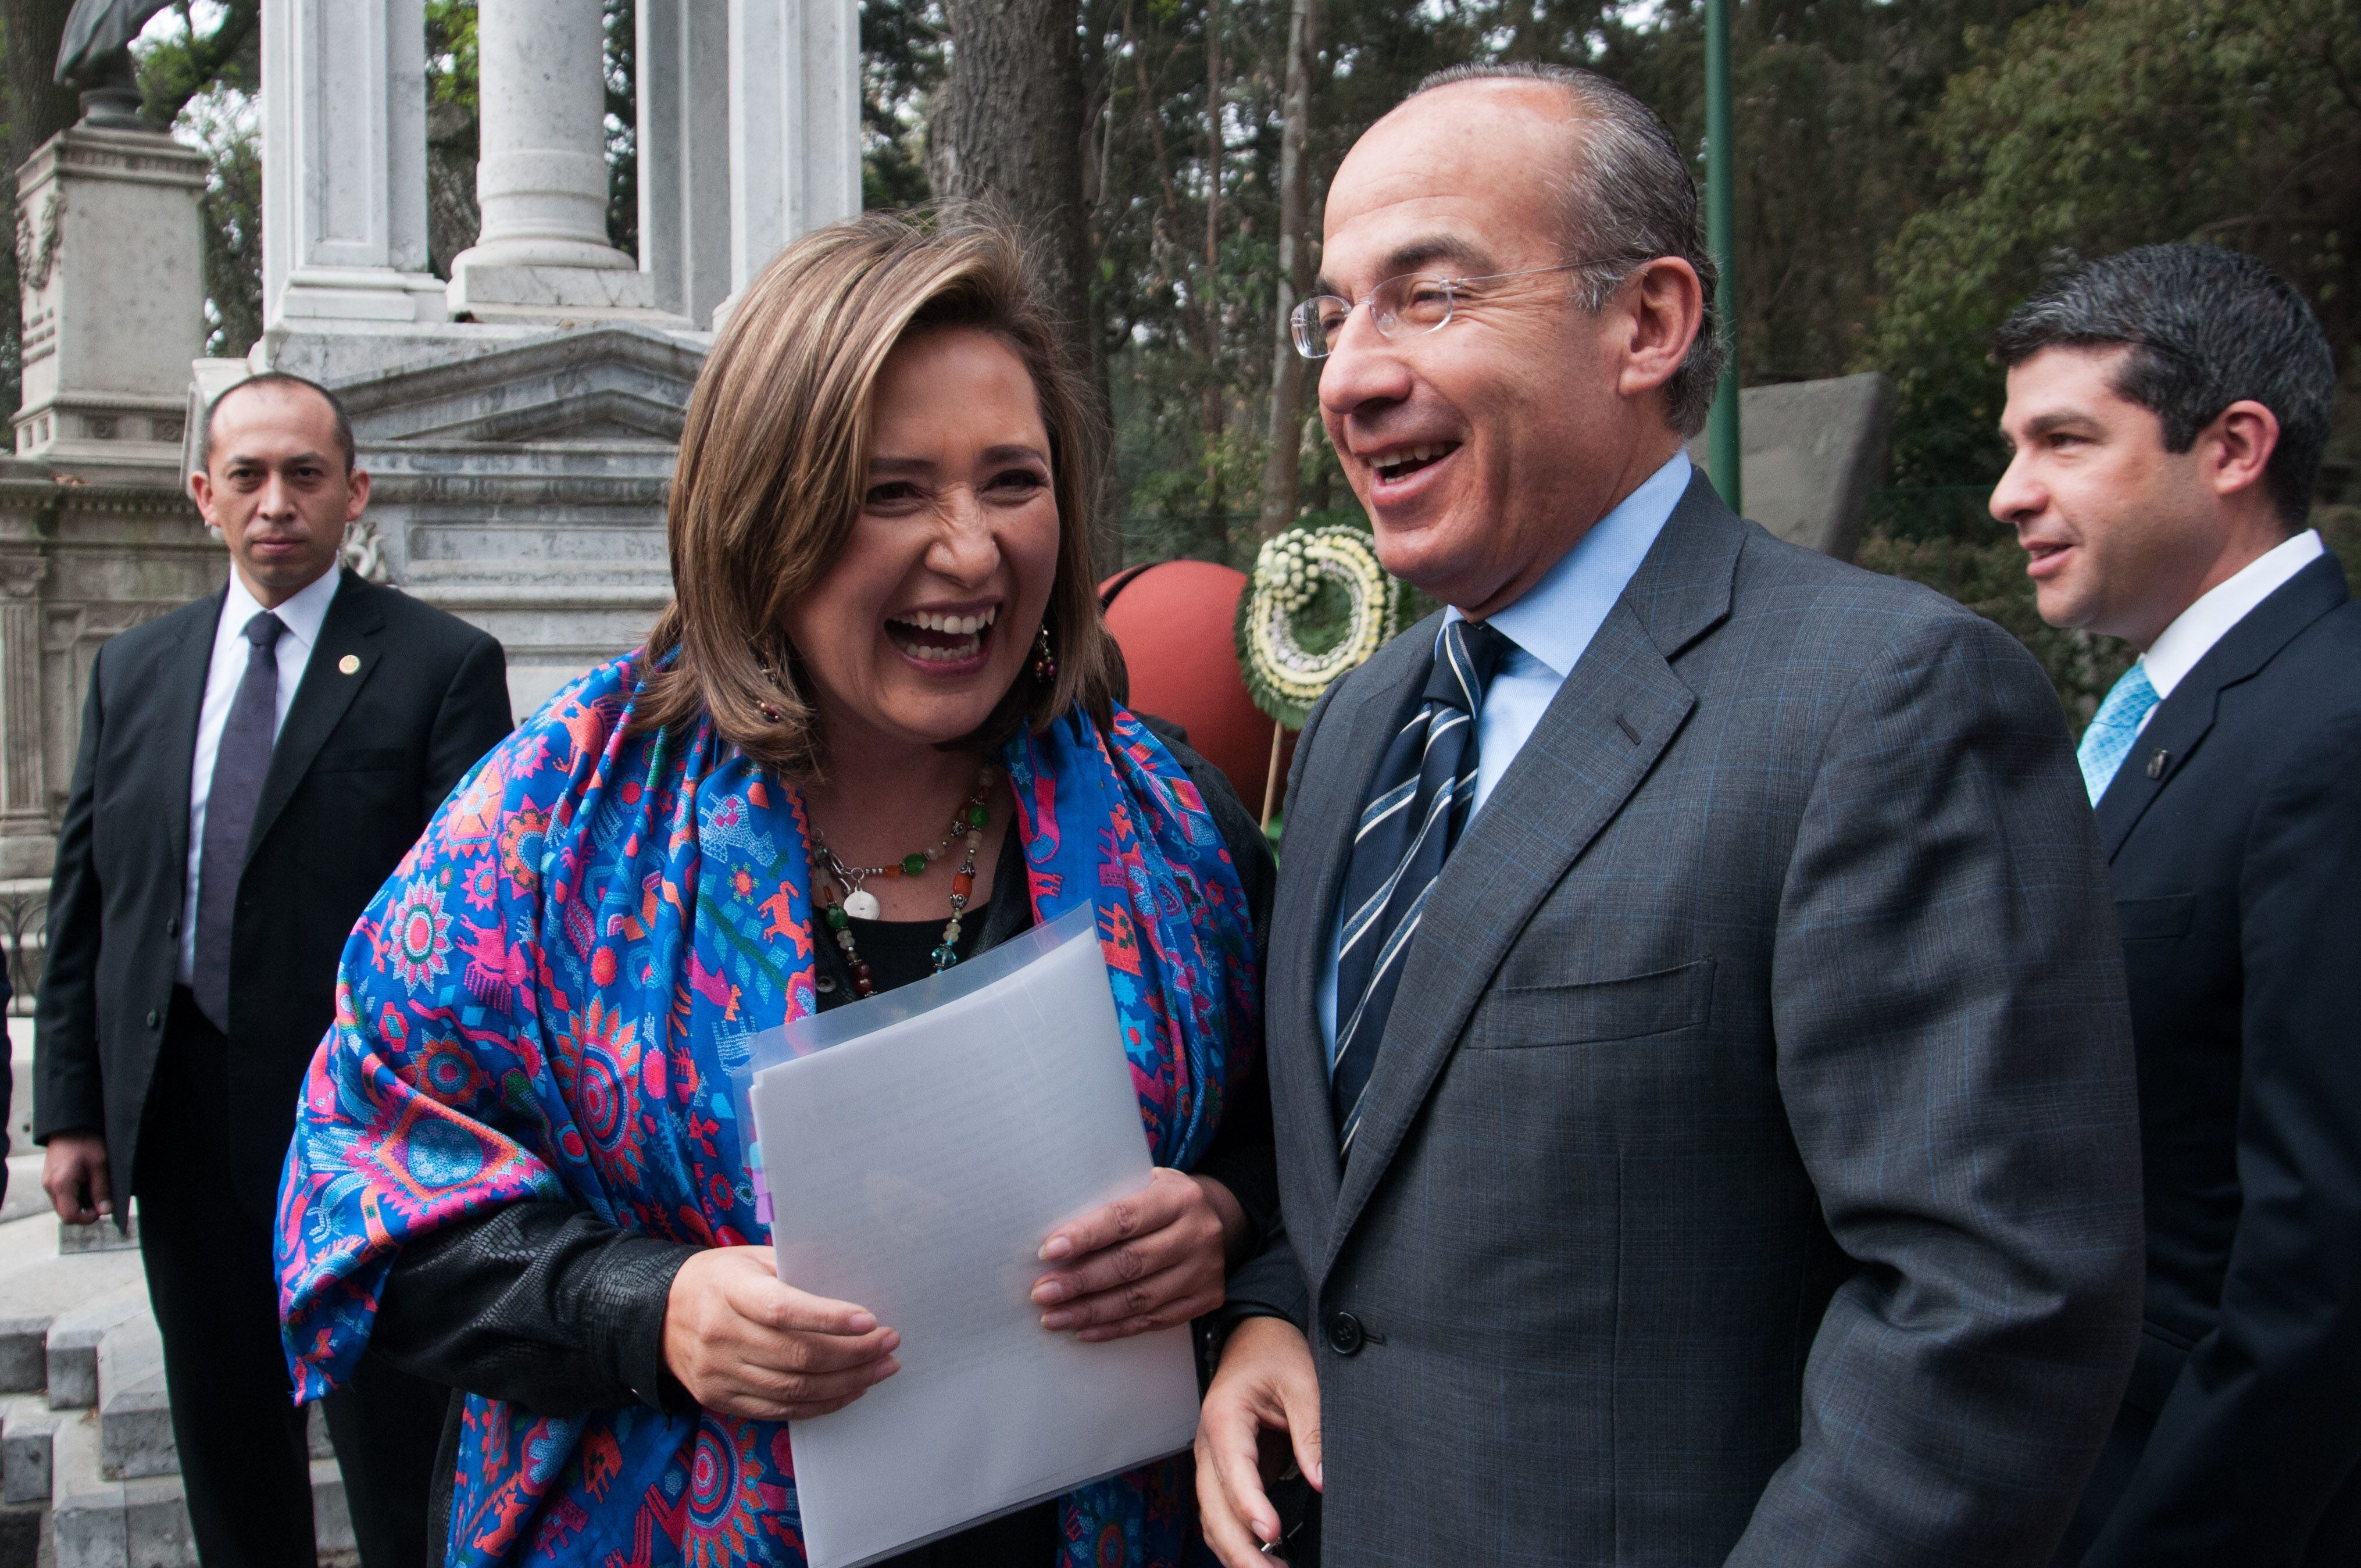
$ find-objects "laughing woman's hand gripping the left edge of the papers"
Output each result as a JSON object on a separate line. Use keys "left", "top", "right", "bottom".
{"left": 663, "top": 1247, "right": 902, "bottom": 1421}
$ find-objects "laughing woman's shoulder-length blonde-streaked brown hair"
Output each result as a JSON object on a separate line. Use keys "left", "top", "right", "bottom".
{"left": 630, "top": 213, "right": 1119, "bottom": 779}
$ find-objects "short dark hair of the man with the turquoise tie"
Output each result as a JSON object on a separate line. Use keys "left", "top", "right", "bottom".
{"left": 1992, "top": 245, "right": 2337, "bottom": 529}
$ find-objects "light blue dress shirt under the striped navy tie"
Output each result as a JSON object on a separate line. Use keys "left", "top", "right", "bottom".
{"left": 1320, "top": 451, "right": 1691, "bottom": 1058}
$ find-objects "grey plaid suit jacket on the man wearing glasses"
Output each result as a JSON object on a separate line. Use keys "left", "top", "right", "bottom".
{"left": 1233, "top": 477, "right": 2141, "bottom": 1568}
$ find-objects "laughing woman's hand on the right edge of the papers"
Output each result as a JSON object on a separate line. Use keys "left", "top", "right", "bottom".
{"left": 1032, "top": 1167, "right": 1246, "bottom": 1341}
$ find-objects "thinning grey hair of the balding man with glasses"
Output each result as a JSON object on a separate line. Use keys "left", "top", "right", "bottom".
{"left": 1409, "top": 62, "right": 1731, "bottom": 437}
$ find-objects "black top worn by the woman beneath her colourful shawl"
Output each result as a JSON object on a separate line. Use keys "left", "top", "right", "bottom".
{"left": 369, "top": 718, "right": 1280, "bottom": 1568}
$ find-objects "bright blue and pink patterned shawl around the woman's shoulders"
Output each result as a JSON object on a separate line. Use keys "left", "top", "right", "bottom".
{"left": 278, "top": 656, "right": 1261, "bottom": 1568}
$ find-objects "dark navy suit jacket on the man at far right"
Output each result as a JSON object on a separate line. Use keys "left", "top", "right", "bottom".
{"left": 2085, "top": 555, "right": 2361, "bottom": 1568}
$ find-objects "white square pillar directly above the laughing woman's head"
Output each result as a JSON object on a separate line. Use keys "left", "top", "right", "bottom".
{"left": 725, "top": 0, "right": 862, "bottom": 312}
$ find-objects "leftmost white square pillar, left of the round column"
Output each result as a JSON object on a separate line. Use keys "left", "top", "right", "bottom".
{"left": 260, "top": 0, "right": 447, "bottom": 347}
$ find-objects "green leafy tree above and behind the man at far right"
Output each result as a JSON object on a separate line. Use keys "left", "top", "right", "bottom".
{"left": 1867, "top": 0, "right": 2361, "bottom": 484}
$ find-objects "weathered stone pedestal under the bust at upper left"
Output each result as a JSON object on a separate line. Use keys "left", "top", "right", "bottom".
{"left": 16, "top": 125, "right": 205, "bottom": 467}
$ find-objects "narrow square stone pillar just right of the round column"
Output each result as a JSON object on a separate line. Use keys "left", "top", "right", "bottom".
{"left": 635, "top": 0, "right": 730, "bottom": 328}
